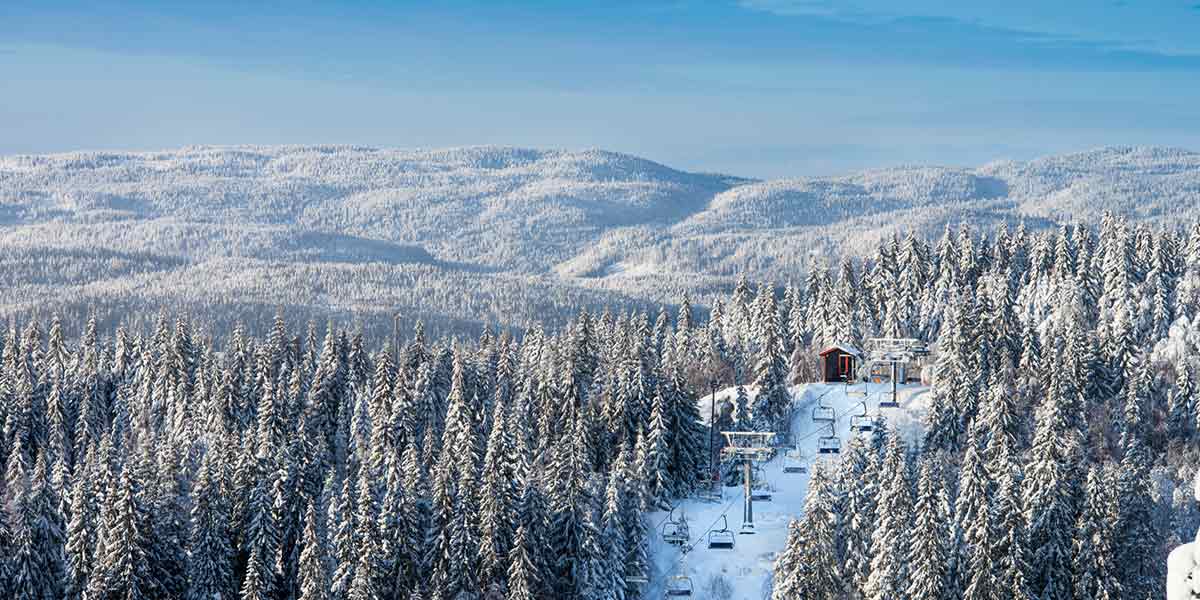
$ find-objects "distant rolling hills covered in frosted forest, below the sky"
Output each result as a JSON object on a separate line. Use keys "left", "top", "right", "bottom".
{"left": 0, "top": 146, "right": 1200, "bottom": 332}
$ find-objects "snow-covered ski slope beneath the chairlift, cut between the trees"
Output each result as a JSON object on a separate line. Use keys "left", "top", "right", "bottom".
{"left": 646, "top": 384, "right": 929, "bottom": 600}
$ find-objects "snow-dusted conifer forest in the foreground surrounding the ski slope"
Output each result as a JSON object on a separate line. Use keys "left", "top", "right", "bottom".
{"left": 0, "top": 215, "right": 1200, "bottom": 600}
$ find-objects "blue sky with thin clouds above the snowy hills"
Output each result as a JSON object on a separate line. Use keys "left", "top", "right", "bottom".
{"left": 0, "top": 0, "right": 1200, "bottom": 178}
